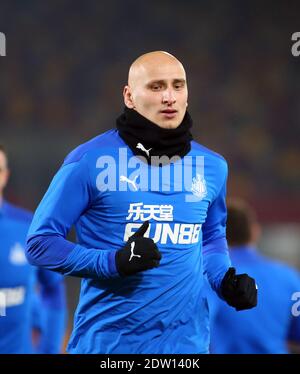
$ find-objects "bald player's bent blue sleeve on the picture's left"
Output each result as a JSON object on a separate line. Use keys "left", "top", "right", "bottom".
{"left": 26, "top": 157, "right": 117, "bottom": 279}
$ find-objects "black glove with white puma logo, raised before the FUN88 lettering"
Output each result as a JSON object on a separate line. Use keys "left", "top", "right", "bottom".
{"left": 115, "top": 221, "right": 161, "bottom": 276}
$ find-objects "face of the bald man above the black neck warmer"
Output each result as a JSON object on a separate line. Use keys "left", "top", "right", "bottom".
{"left": 124, "top": 59, "right": 188, "bottom": 129}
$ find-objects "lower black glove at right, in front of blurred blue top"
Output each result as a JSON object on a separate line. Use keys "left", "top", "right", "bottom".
{"left": 221, "top": 268, "right": 257, "bottom": 310}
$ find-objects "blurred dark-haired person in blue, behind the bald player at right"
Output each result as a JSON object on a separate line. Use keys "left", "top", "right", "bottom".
{"left": 207, "top": 199, "right": 300, "bottom": 353}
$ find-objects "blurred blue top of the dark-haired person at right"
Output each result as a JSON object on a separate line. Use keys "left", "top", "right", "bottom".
{"left": 208, "top": 246, "right": 300, "bottom": 353}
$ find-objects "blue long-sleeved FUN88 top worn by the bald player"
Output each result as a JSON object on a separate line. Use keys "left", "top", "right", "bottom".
{"left": 27, "top": 130, "right": 230, "bottom": 353}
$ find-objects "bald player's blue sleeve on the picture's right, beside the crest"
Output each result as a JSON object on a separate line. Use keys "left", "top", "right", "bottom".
{"left": 203, "top": 164, "right": 231, "bottom": 296}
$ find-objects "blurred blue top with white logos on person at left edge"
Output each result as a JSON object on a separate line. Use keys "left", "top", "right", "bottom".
{"left": 0, "top": 201, "right": 65, "bottom": 353}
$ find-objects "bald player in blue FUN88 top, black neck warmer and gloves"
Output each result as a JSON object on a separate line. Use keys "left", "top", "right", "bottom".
{"left": 27, "top": 51, "right": 257, "bottom": 353}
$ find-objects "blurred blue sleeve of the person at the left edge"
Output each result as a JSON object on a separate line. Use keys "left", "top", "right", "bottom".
{"left": 38, "top": 268, "right": 66, "bottom": 354}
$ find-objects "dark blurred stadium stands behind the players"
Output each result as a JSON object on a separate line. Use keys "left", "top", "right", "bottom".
{"left": 0, "top": 0, "right": 300, "bottom": 344}
